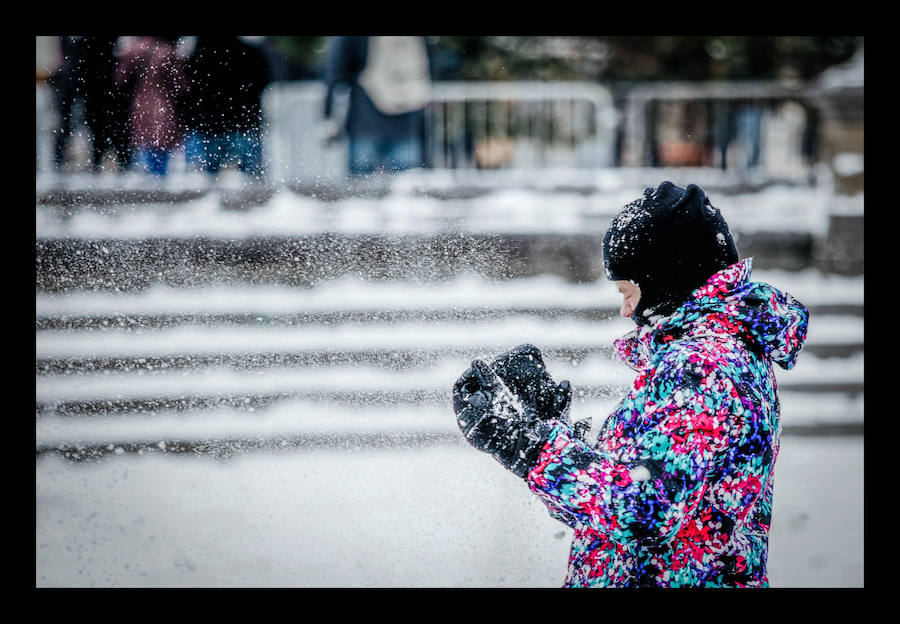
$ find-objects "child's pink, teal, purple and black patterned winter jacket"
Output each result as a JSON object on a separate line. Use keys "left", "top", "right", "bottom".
{"left": 527, "top": 258, "right": 808, "bottom": 587}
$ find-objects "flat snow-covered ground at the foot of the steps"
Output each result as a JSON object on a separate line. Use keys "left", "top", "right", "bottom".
{"left": 35, "top": 437, "right": 864, "bottom": 587}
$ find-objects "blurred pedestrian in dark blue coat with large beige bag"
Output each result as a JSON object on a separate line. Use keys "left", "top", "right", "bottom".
{"left": 324, "top": 36, "right": 431, "bottom": 176}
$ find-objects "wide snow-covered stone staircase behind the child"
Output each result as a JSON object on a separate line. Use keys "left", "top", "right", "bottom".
{"left": 35, "top": 171, "right": 864, "bottom": 459}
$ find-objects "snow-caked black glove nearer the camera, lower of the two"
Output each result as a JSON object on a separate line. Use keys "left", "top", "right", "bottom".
{"left": 453, "top": 360, "right": 550, "bottom": 479}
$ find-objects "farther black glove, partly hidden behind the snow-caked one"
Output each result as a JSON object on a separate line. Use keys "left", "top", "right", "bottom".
{"left": 490, "top": 344, "right": 572, "bottom": 420}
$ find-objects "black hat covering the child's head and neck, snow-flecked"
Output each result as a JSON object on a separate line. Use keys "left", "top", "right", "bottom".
{"left": 603, "top": 182, "right": 738, "bottom": 325}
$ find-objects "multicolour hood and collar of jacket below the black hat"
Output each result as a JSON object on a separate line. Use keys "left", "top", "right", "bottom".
{"left": 615, "top": 258, "right": 809, "bottom": 370}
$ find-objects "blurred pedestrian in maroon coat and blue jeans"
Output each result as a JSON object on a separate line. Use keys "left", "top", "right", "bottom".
{"left": 115, "top": 36, "right": 188, "bottom": 175}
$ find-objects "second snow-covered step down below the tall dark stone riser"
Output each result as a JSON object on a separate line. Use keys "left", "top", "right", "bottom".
{"left": 35, "top": 315, "right": 864, "bottom": 360}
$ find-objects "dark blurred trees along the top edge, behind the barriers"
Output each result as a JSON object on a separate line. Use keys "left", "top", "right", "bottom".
{"left": 268, "top": 35, "right": 863, "bottom": 83}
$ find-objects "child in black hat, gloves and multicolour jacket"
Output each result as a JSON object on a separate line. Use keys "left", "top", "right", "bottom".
{"left": 453, "top": 182, "right": 808, "bottom": 587}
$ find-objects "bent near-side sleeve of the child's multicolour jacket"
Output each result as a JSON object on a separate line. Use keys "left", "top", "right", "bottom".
{"left": 528, "top": 370, "right": 728, "bottom": 544}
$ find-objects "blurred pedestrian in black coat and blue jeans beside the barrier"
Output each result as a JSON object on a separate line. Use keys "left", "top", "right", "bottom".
{"left": 183, "top": 36, "right": 271, "bottom": 176}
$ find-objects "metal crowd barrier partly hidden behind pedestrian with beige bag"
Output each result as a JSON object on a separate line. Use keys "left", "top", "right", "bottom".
{"left": 264, "top": 82, "right": 618, "bottom": 181}
